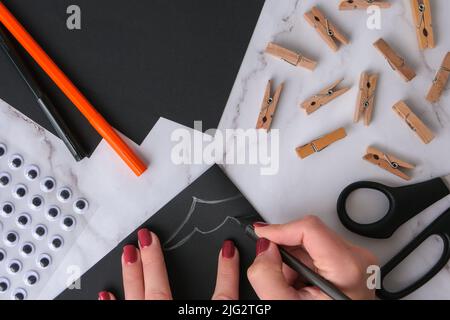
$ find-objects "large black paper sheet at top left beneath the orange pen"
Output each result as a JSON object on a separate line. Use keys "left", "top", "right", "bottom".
{"left": 0, "top": 0, "right": 264, "bottom": 152}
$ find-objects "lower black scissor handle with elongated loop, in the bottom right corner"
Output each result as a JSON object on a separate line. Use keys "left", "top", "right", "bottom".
{"left": 377, "top": 209, "right": 450, "bottom": 300}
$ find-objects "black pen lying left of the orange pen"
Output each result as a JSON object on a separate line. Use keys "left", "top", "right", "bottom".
{"left": 0, "top": 25, "right": 86, "bottom": 161}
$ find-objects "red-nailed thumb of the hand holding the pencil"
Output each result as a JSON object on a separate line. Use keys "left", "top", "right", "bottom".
{"left": 247, "top": 238, "right": 299, "bottom": 300}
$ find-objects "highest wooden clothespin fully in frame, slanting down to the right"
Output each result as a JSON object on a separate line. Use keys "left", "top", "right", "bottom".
{"left": 305, "top": 7, "right": 350, "bottom": 51}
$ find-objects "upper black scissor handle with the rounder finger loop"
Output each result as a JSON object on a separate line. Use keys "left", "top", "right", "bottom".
{"left": 337, "top": 178, "right": 450, "bottom": 239}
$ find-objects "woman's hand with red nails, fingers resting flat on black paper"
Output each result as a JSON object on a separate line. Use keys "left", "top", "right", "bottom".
{"left": 99, "top": 229, "right": 239, "bottom": 300}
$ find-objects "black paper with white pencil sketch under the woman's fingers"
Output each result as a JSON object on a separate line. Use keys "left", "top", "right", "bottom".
{"left": 58, "top": 166, "right": 262, "bottom": 300}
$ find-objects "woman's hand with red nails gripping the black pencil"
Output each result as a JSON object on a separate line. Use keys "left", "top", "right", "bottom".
{"left": 247, "top": 216, "right": 377, "bottom": 300}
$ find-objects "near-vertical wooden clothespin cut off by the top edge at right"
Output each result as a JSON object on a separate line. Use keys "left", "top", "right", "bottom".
{"left": 411, "top": 0, "right": 436, "bottom": 50}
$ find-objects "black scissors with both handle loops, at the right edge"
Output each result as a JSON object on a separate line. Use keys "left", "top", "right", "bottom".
{"left": 337, "top": 175, "right": 450, "bottom": 299}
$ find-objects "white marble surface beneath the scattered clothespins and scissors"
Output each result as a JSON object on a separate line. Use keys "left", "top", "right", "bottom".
{"left": 220, "top": 0, "right": 450, "bottom": 299}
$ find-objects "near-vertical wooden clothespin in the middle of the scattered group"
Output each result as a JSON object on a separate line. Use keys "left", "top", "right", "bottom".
{"left": 354, "top": 72, "right": 378, "bottom": 126}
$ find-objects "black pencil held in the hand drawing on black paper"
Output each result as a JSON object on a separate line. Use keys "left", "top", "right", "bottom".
{"left": 236, "top": 218, "right": 350, "bottom": 300}
